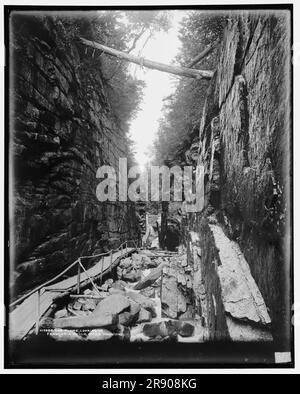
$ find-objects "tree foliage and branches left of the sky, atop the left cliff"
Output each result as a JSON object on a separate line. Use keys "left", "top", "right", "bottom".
{"left": 49, "top": 10, "right": 169, "bottom": 163}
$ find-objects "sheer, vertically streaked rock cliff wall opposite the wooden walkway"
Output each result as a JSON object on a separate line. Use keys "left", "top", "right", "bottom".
{"left": 182, "top": 12, "right": 291, "bottom": 348}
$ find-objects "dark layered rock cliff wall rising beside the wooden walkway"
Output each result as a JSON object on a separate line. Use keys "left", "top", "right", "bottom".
{"left": 9, "top": 15, "right": 138, "bottom": 293}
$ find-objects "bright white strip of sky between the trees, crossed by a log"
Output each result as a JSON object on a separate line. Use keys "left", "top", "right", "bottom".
{"left": 130, "top": 10, "right": 185, "bottom": 166}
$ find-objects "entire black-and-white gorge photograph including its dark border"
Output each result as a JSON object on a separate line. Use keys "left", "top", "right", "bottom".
{"left": 4, "top": 2, "right": 297, "bottom": 370}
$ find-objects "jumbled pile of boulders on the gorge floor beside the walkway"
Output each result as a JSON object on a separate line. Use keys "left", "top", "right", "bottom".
{"left": 42, "top": 252, "right": 194, "bottom": 341}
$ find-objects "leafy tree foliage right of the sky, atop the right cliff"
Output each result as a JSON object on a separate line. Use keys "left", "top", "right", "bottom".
{"left": 153, "top": 11, "right": 227, "bottom": 164}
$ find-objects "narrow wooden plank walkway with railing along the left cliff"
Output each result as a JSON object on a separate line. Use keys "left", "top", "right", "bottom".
{"left": 9, "top": 248, "right": 135, "bottom": 340}
